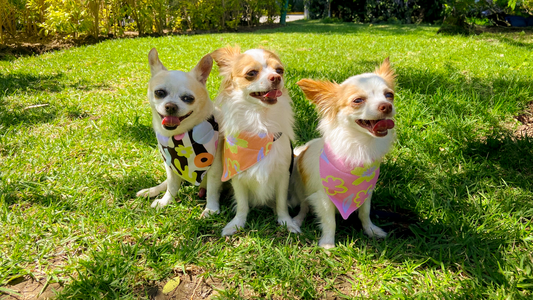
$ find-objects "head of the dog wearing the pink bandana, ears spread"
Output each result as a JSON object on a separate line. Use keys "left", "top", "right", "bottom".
{"left": 297, "top": 58, "right": 396, "bottom": 138}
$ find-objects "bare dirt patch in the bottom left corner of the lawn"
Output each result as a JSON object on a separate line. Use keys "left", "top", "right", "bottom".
{"left": 0, "top": 277, "right": 62, "bottom": 300}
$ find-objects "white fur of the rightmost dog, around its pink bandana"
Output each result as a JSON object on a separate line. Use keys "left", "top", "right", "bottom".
{"left": 291, "top": 69, "right": 395, "bottom": 249}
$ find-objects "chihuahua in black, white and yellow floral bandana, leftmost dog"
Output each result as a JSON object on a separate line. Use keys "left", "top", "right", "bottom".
{"left": 137, "top": 48, "right": 223, "bottom": 216}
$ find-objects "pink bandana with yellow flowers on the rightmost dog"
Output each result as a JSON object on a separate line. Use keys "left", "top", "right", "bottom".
{"left": 320, "top": 144, "right": 379, "bottom": 220}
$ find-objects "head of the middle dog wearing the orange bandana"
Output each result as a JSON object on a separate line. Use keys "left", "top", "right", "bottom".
{"left": 211, "top": 46, "right": 284, "bottom": 106}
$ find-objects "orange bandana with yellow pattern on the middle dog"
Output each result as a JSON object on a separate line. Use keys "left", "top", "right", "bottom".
{"left": 222, "top": 133, "right": 281, "bottom": 181}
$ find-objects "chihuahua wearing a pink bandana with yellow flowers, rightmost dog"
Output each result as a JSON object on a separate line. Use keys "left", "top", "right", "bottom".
{"left": 291, "top": 58, "right": 396, "bottom": 248}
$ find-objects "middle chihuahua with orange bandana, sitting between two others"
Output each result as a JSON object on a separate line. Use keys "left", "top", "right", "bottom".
{"left": 211, "top": 46, "right": 300, "bottom": 235}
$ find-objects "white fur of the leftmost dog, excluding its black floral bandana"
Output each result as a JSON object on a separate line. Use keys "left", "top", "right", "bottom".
{"left": 137, "top": 48, "right": 224, "bottom": 216}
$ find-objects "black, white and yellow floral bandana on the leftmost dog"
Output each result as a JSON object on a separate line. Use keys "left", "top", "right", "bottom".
{"left": 156, "top": 116, "right": 218, "bottom": 185}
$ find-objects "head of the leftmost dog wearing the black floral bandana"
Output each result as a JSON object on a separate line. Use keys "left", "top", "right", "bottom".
{"left": 148, "top": 48, "right": 213, "bottom": 133}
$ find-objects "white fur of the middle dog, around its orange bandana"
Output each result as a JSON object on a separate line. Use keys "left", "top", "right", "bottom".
{"left": 216, "top": 49, "right": 300, "bottom": 235}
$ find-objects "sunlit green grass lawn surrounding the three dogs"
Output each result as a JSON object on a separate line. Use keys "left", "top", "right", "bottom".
{"left": 0, "top": 21, "right": 533, "bottom": 299}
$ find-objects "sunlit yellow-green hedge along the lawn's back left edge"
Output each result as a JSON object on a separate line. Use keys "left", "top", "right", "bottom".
{"left": 0, "top": 0, "right": 281, "bottom": 42}
